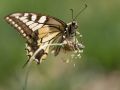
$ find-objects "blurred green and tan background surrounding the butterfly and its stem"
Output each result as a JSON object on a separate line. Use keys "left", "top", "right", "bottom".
{"left": 0, "top": 0, "right": 120, "bottom": 90}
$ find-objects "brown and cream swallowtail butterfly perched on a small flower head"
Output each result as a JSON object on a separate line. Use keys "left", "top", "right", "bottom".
{"left": 5, "top": 6, "right": 84, "bottom": 64}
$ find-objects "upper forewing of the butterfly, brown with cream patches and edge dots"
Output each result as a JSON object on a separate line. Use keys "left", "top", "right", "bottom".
{"left": 6, "top": 13, "right": 66, "bottom": 39}
